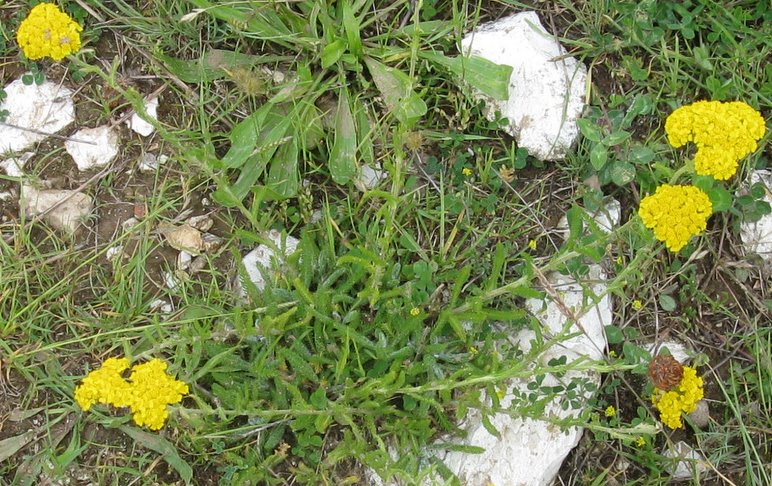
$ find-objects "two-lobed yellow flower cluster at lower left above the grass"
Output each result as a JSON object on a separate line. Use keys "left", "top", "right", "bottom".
{"left": 75, "top": 358, "right": 188, "bottom": 430}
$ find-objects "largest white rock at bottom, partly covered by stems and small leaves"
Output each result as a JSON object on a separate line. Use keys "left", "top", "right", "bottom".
{"left": 434, "top": 265, "right": 612, "bottom": 486}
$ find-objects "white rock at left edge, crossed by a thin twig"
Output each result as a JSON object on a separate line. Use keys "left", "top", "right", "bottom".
{"left": 0, "top": 78, "right": 75, "bottom": 154}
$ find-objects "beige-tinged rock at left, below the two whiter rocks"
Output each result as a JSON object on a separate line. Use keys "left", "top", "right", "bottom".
{"left": 19, "top": 186, "right": 94, "bottom": 234}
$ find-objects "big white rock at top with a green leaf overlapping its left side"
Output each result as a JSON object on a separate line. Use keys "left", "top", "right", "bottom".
{"left": 461, "top": 11, "right": 587, "bottom": 160}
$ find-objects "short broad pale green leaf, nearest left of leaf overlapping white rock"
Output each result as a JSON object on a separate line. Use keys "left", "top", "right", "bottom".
{"left": 365, "top": 57, "right": 426, "bottom": 125}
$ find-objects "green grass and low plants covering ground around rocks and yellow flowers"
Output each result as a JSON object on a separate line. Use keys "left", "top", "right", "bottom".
{"left": 0, "top": 0, "right": 772, "bottom": 485}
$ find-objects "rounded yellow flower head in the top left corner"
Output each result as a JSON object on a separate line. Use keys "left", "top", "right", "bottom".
{"left": 16, "top": 3, "right": 83, "bottom": 61}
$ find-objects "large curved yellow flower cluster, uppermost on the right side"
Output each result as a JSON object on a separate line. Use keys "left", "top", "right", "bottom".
{"left": 665, "top": 101, "right": 766, "bottom": 180}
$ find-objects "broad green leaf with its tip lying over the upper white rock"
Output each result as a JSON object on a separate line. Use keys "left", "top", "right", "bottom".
{"left": 419, "top": 52, "right": 512, "bottom": 100}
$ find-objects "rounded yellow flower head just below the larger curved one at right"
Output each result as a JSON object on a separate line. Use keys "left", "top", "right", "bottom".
{"left": 638, "top": 184, "right": 713, "bottom": 252}
